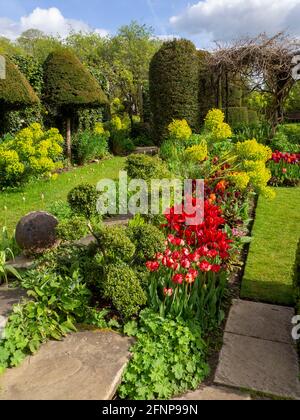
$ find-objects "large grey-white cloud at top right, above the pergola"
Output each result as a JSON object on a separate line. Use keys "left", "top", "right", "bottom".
{"left": 170, "top": 0, "right": 300, "bottom": 41}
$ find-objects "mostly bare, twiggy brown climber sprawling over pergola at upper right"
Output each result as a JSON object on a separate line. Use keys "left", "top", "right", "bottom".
{"left": 207, "top": 32, "right": 300, "bottom": 133}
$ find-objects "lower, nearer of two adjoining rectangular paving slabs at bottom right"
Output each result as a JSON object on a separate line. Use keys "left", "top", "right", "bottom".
{"left": 215, "top": 333, "right": 300, "bottom": 399}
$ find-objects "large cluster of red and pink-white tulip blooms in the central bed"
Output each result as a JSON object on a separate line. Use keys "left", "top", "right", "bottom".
{"left": 146, "top": 201, "right": 232, "bottom": 296}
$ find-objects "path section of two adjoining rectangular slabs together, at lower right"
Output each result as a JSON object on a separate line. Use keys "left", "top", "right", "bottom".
{"left": 215, "top": 300, "right": 300, "bottom": 399}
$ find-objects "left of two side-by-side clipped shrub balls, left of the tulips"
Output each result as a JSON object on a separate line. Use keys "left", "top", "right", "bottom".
{"left": 96, "top": 226, "right": 135, "bottom": 262}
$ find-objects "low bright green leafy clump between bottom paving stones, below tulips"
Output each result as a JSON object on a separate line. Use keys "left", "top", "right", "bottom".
{"left": 119, "top": 310, "right": 209, "bottom": 400}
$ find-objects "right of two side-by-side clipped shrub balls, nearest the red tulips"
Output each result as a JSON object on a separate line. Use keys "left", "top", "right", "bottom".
{"left": 127, "top": 224, "right": 165, "bottom": 264}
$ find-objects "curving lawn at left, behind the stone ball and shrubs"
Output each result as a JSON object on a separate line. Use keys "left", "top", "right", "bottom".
{"left": 0, "top": 157, "right": 125, "bottom": 232}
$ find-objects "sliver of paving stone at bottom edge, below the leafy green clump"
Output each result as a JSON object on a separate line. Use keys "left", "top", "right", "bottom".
{"left": 174, "top": 386, "right": 251, "bottom": 401}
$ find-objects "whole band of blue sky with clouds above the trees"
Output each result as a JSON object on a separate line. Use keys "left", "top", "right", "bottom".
{"left": 0, "top": 0, "right": 300, "bottom": 48}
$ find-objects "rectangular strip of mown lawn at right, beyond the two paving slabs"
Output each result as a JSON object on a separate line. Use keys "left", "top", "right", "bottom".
{"left": 241, "top": 188, "right": 300, "bottom": 305}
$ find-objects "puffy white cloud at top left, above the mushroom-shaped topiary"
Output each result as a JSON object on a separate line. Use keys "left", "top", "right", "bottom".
{"left": 0, "top": 7, "right": 108, "bottom": 39}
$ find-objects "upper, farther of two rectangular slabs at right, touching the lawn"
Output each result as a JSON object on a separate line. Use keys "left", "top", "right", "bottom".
{"left": 225, "top": 300, "right": 295, "bottom": 343}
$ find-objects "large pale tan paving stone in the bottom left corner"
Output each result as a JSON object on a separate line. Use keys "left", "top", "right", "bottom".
{"left": 0, "top": 331, "right": 132, "bottom": 400}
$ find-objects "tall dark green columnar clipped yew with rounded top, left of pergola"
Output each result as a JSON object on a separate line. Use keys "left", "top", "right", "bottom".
{"left": 150, "top": 40, "right": 200, "bottom": 143}
